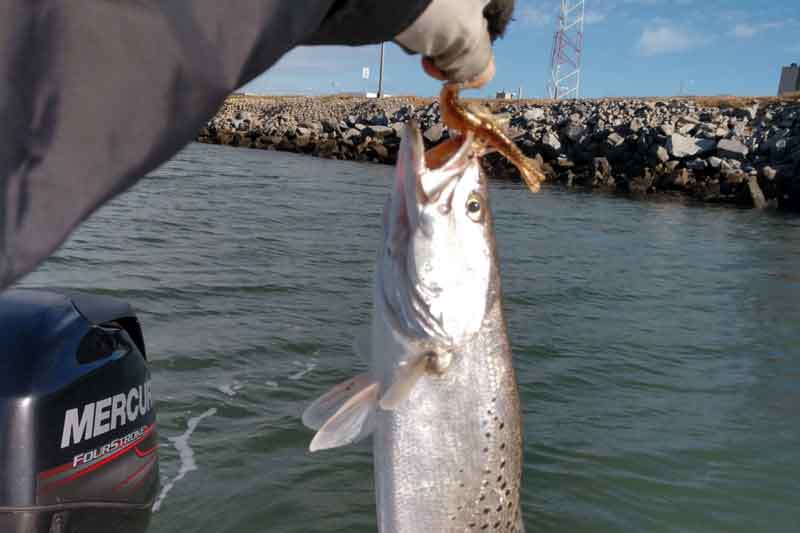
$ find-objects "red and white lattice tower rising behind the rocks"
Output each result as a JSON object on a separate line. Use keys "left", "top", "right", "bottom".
{"left": 547, "top": 0, "right": 586, "bottom": 100}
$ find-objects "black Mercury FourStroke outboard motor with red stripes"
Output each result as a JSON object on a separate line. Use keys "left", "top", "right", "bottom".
{"left": 0, "top": 289, "right": 159, "bottom": 533}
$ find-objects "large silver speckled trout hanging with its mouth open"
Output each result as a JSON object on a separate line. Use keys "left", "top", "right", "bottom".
{"left": 303, "top": 125, "right": 524, "bottom": 533}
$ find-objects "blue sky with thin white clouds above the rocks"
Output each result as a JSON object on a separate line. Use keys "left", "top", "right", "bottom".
{"left": 242, "top": 0, "right": 800, "bottom": 98}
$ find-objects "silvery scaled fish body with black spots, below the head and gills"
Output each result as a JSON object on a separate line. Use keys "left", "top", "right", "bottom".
{"left": 374, "top": 300, "right": 522, "bottom": 533}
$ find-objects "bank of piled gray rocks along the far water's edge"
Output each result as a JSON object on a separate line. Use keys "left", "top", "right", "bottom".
{"left": 197, "top": 92, "right": 800, "bottom": 211}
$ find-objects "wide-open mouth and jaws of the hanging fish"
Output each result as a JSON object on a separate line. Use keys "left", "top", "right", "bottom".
{"left": 384, "top": 122, "right": 475, "bottom": 234}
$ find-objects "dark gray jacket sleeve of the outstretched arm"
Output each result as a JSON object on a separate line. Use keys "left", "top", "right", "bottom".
{"left": 0, "top": 0, "right": 429, "bottom": 289}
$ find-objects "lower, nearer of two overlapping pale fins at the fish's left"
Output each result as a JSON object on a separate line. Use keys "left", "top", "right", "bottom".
{"left": 304, "top": 376, "right": 379, "bottom": 452}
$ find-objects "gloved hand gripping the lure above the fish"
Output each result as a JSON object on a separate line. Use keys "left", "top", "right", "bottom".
{"left": 395, "top": 0, "right": 514, "bottom": 87}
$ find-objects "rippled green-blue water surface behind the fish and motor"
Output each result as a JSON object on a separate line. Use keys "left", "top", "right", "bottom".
{"left": 22, "top": 144, "right": 800, "bottom": 533}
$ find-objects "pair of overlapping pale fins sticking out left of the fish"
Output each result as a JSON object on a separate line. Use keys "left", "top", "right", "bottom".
{"left": 303, "top": 373, "right": 379, "bottom": 452}
